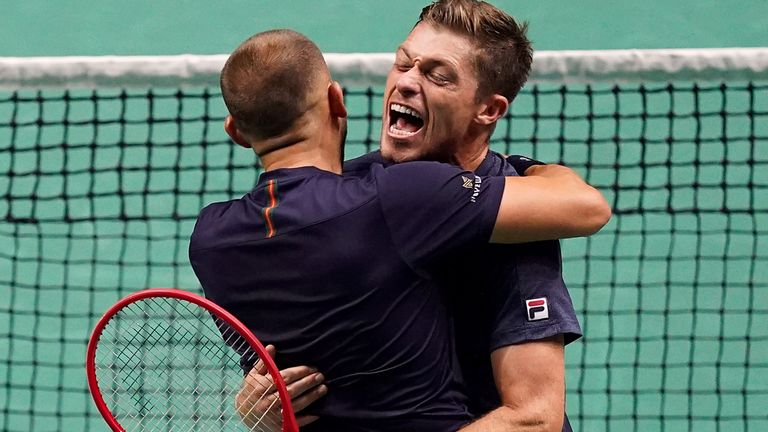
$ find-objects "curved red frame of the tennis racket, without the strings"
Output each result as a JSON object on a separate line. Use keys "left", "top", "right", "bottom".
{"left": 85, "top": 288, "right": 299, "bottom": 432}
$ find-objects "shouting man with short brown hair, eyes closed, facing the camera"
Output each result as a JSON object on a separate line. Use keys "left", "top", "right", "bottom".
{"left": 256, "top": 0, "right": 581, "bottom": 431}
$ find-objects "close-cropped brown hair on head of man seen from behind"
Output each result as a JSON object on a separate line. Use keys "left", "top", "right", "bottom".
{"left": 221, "top": 30, "right": 330, "bottom": 140}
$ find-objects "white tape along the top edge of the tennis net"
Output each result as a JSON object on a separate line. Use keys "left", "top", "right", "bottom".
{"left": 0, "top": 48, "right": 768, "bottom": 90}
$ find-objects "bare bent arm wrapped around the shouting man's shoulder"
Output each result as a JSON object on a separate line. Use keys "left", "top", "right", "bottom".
{"left": 491, "top": 165, "right": 611, "bottom": 243}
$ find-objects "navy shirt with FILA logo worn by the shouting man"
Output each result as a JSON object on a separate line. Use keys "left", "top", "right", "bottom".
{"left": 344, "top": 151, "right": 581, "bottom": 431}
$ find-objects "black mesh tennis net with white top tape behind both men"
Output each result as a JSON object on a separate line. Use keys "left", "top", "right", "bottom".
{"left": 0, "top": 49, "right": 768, "bottom": 432}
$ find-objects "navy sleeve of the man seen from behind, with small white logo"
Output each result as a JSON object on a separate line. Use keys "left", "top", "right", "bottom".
{"left": 373, "top": 162, "right": 504, "bottom": 268}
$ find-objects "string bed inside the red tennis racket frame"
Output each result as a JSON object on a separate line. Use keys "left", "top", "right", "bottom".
{"left": 97, "top": 298, "right": 282, "bottom": 432}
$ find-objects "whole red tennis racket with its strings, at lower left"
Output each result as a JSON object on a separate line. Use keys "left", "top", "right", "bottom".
{"left": 86, "top": 289, "right": 298, "bottom": 432}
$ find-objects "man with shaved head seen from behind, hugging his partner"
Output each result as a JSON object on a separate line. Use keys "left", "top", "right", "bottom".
{"left": 190, "top": 30, "right": 610, "bottom": 431}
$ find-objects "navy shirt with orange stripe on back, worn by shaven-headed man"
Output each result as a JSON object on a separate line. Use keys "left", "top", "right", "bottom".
{"left": 190, "top": 162, "right": 504, "bottom": 431}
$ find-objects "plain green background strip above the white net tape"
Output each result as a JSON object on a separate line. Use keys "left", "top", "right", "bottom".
{"left": 0, "top": 0, "right": 768, "bottom": 56}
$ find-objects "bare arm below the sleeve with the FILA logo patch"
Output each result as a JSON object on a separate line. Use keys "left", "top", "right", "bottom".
{"left": 460, "top": 336, "right": 565, "bottom": 432}
